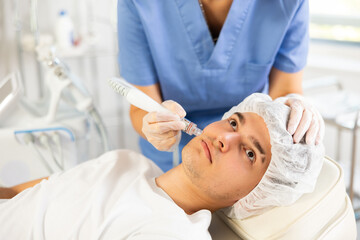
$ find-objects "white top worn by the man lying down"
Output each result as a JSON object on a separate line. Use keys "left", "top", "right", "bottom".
{"left": 0, "top": 150, "right": 211, "bottom": 240}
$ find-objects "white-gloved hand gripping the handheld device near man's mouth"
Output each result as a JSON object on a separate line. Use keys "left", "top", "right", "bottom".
{"left": 142, "top": 100, "right": 186, "bottom": 152}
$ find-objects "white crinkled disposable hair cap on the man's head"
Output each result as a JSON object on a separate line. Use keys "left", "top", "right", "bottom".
{"left": 223, "top": 93, "right": 324, "bottom": 219}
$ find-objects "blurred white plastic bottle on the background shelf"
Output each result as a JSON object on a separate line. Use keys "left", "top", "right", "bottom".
{"left": 55, "top": 10, "right": 75, "bottom": 49}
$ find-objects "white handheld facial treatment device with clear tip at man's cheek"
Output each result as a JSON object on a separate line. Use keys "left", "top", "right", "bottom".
{"left": 108, "top": 77, "right": 202, "bottom": 136}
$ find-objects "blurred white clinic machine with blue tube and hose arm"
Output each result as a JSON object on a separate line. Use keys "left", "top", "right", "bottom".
{"left": 0, "top": 46, "right": 110, "bottom": 186}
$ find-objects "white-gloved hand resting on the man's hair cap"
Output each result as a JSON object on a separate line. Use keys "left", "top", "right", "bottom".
{"left": 278, "top": 94, "right": 325, "bottom": 145}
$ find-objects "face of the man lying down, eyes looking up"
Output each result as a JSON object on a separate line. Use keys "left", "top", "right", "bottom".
{"left": 182, "top": 112, "right": 271, "bottom": 206}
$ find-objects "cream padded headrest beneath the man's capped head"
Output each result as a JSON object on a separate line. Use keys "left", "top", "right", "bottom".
{"left": 209, "top": 157, "right": 357, "bottom": 240}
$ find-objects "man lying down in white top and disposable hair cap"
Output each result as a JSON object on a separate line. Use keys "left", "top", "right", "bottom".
{"left": 0, "top": 94, "right": 324, "bottom": 240}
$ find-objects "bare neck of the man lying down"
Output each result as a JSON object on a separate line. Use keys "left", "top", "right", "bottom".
{"left": 156, "top": 164, "right": 221, "bottom": 214}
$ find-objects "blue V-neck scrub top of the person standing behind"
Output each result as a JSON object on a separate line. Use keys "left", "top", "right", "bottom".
{"left": 118, "top": 0, "right": 309, "bottom": 171}
